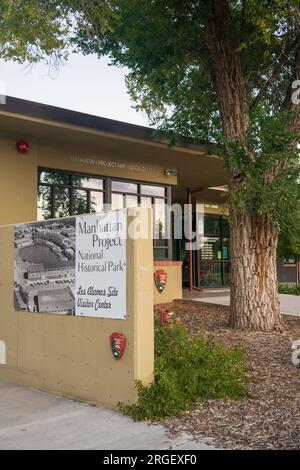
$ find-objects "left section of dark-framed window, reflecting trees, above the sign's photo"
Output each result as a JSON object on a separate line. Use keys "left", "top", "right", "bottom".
{"left": 38, "top": 170, "right": 104, "bottom": 220}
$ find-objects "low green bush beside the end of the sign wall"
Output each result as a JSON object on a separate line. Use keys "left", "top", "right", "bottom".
{"left": 119, "top": 319, "right": 250, "bottom": 421}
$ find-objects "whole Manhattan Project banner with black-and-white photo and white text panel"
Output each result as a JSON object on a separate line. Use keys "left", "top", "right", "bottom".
{"left": 14, "top": 210, "right": 127, "bottom": 319}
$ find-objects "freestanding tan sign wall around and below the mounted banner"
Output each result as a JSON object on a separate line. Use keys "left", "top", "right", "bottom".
{"left": 0, "top": 209, "right": 154, "bottom": 408}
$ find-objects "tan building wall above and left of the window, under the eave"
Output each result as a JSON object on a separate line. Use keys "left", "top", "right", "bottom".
{"left": 0, "top": 135, "right": 177, "bottom": 226}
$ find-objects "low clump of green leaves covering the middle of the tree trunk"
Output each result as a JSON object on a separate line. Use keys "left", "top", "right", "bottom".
{"left": 227, "top": 106, "right": 300, "bottom": 236}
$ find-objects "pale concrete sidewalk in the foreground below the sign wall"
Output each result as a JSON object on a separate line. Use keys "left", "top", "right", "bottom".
{"left": 0, "top": 381, "right": 214, "bottom": 450}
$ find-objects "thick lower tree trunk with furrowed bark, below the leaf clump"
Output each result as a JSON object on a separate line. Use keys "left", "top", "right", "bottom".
{"left": 229, "top": 210, "right": 284, "bottom": 331}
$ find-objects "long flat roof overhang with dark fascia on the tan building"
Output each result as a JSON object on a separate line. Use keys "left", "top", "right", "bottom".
{"left": 0, "top": 98, "right": 225, "bottom": 195}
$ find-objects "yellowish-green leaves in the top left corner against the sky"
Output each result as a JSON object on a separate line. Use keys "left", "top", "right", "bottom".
{"left": 0, "top": 0, "right": 119, "bottom": 66}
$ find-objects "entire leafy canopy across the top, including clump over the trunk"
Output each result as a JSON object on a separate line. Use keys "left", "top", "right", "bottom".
{"left": 0, "top": 0, "right": 300, "bottom": 246}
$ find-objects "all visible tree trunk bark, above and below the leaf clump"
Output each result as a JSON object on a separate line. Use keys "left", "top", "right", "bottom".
{"left": 208, "top": 0, "right": 284, "bottom": 331}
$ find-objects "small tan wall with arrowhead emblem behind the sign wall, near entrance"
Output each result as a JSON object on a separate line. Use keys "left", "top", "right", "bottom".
{"left": 153, "top": 261, "right": 182, "bottom": 305}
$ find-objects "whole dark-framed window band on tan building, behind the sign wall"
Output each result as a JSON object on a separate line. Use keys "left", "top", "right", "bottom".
{"left": 38, "top": 169, "right": 171, "bottom": 259}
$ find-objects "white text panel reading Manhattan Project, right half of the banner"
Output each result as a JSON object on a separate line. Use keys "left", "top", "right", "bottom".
{"left": 75, "top": 211, "right": 127, "bottom": 319}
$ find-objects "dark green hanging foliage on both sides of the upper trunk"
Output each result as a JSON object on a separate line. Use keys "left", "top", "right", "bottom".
{"left": 66, "top": 0, "right": 299, "bottom": 142}
